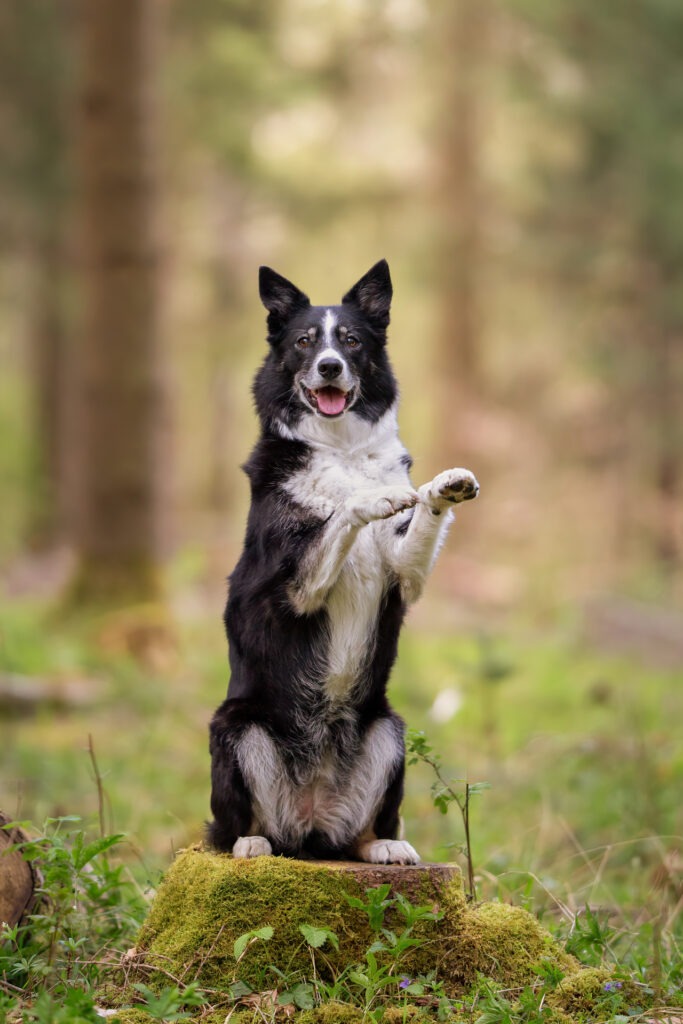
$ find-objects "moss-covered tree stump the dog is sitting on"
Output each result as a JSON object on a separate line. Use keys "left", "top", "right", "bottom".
{"left": 107, "top": 848, "right": 643, "bottom": 1024}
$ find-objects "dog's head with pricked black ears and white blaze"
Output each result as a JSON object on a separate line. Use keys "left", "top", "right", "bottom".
{"left": 254, "top": 260, "right": 396, "bottom": 427}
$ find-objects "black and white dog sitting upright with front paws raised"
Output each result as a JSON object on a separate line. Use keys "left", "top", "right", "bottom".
{"left": 208, "top": 260, "right": 479, "bottom": 863}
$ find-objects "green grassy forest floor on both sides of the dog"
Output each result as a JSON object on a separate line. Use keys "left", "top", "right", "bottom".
{"left": 0, "top": 604, "right": 683, "bottom": 1021}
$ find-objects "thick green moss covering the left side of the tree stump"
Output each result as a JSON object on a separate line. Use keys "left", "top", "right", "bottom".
{"left": 137, "top": 850, "right": 372, "bottom": 991}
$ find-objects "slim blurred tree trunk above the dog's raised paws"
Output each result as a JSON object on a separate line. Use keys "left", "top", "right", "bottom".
{"left": 435, "top": 0, "right": 487, "bottom": 428}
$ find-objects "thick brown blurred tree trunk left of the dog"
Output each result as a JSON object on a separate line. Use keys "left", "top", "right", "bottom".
{"left": 75, "top": 0, "right": 170, "bottom": 600}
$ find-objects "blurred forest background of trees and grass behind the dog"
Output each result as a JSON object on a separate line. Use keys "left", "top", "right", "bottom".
{"left": 0, "top": 0, "right": 683, "bottom": 937}
